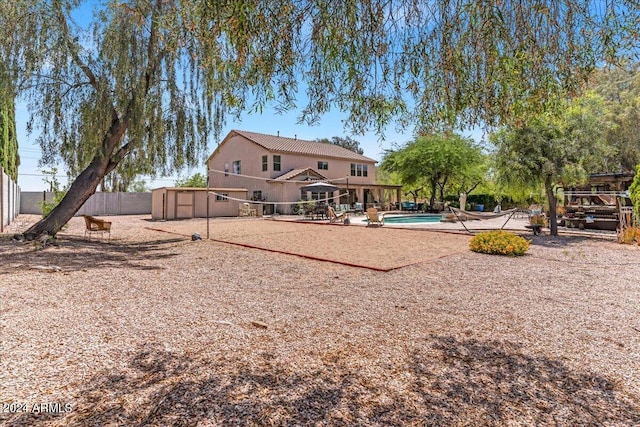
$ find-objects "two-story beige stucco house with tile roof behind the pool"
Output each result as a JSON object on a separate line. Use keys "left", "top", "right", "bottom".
{"left": 207, "top": 130, "right": 401, "bottom": 214}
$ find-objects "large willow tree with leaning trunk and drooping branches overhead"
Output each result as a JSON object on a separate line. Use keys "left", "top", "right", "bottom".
{"left": 0, "top": 0, "right": 638, "bottom": 235}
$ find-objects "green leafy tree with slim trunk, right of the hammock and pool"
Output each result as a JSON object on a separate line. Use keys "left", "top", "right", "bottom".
{"left": 490, "top": 93, "right": 610, "bottom": 235}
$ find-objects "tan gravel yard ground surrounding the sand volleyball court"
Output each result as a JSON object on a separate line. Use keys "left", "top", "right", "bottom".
{"left": 0, "top": 217, "right": 640, "bottom": 426}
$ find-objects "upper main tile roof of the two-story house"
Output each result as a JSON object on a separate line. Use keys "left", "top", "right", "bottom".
{"left": 231, "top": 130, "right": 376, "bottom": 163}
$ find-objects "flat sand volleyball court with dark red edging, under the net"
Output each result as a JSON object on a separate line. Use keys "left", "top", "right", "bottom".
{"left": 149, "top": 218, "right": 469, "bottom": 271}
